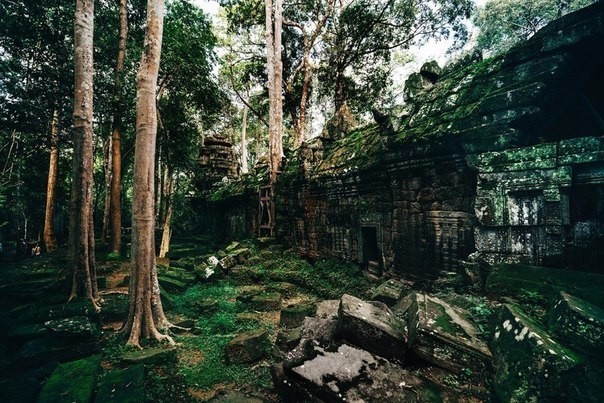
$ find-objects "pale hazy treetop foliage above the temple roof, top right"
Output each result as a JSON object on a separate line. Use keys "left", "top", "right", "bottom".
{"left": 474, "top": 0, "right": 594, "bottom": 54}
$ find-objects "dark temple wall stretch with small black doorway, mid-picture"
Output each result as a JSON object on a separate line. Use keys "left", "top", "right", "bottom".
{"left": 278, "top": 142, "right": 476, "bottom": 277}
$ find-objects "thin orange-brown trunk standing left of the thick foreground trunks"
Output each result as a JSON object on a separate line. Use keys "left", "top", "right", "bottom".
{"left": 44, "top": 109, "right": 59, "bottom": 252}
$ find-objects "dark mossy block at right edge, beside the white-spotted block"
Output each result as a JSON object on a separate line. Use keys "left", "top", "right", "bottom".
{"left": 549, "top": 291, "right": 604, "bottom": 360}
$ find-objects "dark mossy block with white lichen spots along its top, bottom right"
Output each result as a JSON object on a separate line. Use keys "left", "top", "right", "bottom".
{"left": 491, "top": 304, "right": 581, "bottom": 402}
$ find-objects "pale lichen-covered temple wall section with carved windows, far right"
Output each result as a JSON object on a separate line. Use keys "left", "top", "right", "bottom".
{"left": 469, "top": 137, "right": 604, "bottom": 270}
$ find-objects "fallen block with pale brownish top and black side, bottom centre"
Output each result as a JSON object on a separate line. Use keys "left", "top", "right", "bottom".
{"left": 338, "top": 294, "right": 407, "bottom": 359}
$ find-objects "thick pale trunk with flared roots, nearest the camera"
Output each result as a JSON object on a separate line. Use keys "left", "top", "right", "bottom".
{"left": 122, "top": 0, "right": 174, "bottom": 347}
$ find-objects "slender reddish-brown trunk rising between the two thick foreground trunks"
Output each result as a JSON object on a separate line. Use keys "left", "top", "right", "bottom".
{"left": 109, "top": 0, "right": 128, "bottom": 254}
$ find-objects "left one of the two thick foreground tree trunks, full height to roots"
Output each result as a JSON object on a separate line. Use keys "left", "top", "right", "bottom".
{"left": 67, "top": 0, "right": 100, "bottom": 310}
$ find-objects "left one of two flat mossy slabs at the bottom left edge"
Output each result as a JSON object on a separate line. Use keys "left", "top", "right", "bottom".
{"left": 38, "top": 355, "right": 101, "bottom": 403}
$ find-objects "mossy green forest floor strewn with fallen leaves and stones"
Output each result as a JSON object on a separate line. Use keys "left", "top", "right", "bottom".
{"left": 0, "top": 237, "right": 599, "bottom": 402}
